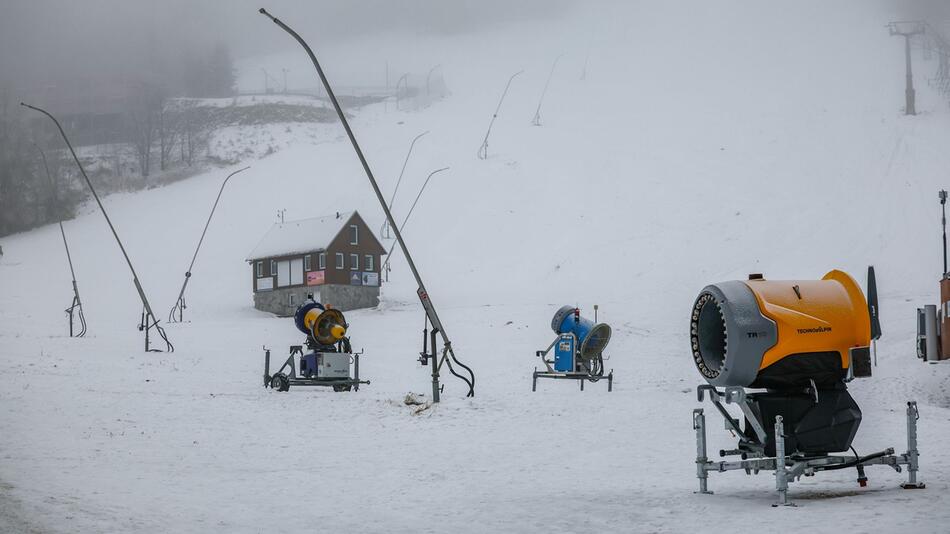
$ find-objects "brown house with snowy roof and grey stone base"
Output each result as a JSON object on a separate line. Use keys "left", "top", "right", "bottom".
{"left": 247, "top": 211, "right": 386, "bottom": 316}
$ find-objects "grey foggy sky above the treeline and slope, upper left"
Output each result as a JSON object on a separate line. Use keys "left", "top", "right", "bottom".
{"left": 0, "top": 0, "right": 570, "bottom": 89}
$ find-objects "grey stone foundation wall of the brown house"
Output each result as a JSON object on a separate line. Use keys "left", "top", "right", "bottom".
{"left": 254, "top": 284, "right": 379, "bottom": 317}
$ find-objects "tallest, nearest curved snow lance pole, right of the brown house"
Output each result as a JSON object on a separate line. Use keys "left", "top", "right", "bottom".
{"left": 260, "top": 8, "right": 475, "bottom": 402}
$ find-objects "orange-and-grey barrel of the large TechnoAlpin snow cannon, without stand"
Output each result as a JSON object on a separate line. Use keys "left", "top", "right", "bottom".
{"left": 690, "top": 271, "right": 871, "bottom": 389}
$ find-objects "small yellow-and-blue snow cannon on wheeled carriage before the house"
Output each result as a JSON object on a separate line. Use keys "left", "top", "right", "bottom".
{"left": 264, "top": 297, "right": 369, "bottom": 391}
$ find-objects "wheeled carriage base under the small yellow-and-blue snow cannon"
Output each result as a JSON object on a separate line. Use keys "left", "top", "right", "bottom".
{"left": 264, "top": 345, "right": 370, "bottom": 392}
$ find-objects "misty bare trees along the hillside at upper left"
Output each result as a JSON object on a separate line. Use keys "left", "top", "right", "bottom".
{"left": 0, "top": 44, "right": 236, "bottom": 236}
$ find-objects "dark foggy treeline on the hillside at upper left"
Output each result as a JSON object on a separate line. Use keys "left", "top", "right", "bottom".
{"left": 0, "top": 44, "right": 235, "bottom": 239}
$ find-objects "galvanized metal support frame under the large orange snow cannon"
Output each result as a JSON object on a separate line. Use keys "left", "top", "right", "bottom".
{"left": 693, "top": 385, "right": 925, "bottom": 506}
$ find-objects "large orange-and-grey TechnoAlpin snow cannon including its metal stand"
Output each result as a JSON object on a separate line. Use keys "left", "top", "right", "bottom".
{"left": 690, "top": 270, "right": 920, "bottom": 504}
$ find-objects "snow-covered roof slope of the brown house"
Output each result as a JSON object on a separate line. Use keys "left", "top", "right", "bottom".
{"left": 247, "top": 212, "right": 354, "bottom": 261}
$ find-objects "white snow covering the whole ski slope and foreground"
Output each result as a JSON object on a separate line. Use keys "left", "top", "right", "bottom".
{"left": 0, "top": 1, "right": 950, "bottom": 533}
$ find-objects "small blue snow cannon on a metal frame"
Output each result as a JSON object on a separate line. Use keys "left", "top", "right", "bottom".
{"left": 531, "top": 305, "right": 614, "bottom": 391}
